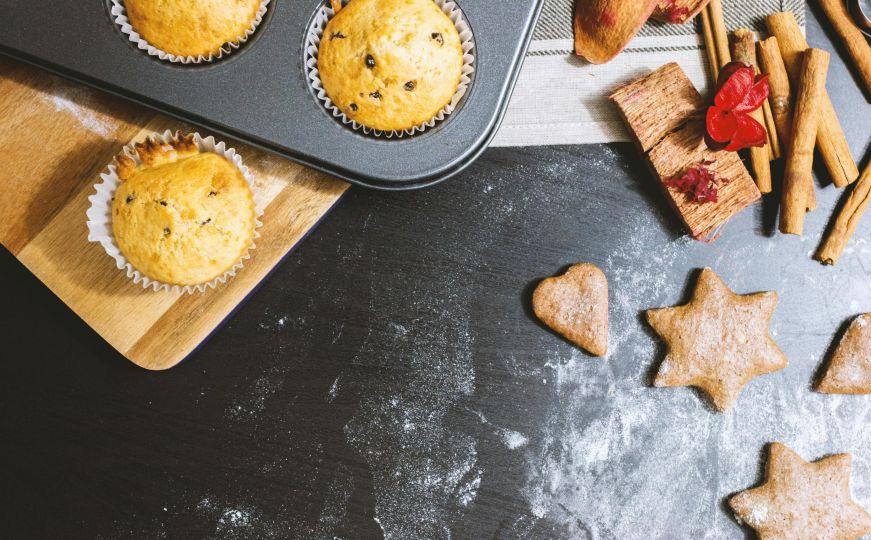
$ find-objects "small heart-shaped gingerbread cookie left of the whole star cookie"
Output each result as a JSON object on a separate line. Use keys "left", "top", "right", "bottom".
{"left": 532, "top": 264, "right": 608, "bottom": 356}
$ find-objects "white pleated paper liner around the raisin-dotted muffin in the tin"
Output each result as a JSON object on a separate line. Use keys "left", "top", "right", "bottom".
{"left": 304, "top": 0, "right": 475, "bottom": 139}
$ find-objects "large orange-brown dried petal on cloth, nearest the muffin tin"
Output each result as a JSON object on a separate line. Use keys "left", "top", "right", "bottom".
{"left": 574, "top": 0, "right": 660, "bottom": 64}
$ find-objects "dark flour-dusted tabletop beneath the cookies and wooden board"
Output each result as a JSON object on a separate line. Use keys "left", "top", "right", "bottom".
{"left": 0, "top": 5, "right": 871, "bottom": 538}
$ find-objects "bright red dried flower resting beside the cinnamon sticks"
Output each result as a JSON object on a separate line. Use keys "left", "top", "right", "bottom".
{"left": 705, "top": 62, "right": 768, "bottom": 152}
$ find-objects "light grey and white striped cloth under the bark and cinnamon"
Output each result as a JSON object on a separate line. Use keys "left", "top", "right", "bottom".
{"left": 492, "top": 0, "right": 805, "bottom": 146}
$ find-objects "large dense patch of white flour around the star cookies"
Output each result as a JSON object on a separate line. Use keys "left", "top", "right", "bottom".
{"left": 513, "top": 209, "right": 871, "bottom": 539}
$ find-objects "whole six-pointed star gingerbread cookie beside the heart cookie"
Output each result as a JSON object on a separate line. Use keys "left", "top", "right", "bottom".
{"left": 647, "top": 268, "right": 787, "bottom": 411}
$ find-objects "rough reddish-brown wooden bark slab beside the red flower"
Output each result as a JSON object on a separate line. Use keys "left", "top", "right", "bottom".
{"left": 611, "top": 63, "right": 761, "bottom": 239}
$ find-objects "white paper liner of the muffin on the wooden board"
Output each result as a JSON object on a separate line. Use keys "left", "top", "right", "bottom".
{"left": 87, "top": 130, "right": 264, "bottom": 294}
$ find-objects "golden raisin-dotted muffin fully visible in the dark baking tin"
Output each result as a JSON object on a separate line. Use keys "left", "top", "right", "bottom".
{"left": 318, "top": 0, "right": 463, "bottom": 131}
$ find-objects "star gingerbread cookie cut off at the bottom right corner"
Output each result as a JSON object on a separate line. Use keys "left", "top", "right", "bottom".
{"left": 729, "top": 443, "right": 871, "bottom": 540}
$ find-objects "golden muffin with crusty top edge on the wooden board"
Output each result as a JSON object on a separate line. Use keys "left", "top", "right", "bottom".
{"left": 112, "top": 135, "right": 256, "bottom": 286}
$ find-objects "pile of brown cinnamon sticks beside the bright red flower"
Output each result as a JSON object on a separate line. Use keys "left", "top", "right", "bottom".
{"left": 701, "top": 7, "right": 871, "bottom": 264}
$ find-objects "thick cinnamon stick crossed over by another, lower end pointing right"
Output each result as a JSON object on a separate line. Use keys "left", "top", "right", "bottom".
{"left": 765, "top": 11, "right": 859, "bottom": 187}
